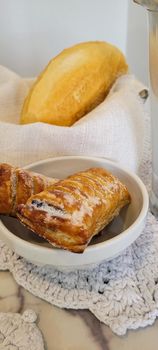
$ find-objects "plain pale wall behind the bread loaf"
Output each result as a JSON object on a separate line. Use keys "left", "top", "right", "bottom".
{"left": 0, "top": 0, "right": 148, "bottom": 83}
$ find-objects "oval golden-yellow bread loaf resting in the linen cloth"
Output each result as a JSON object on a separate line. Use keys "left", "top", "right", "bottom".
{"left": 20, "top": 41, "right": 128, "bottom": 126}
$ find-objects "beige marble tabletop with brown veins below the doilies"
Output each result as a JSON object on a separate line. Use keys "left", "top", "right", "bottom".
{"left": 0, "top": 272, "right": 158, "bottom": 350}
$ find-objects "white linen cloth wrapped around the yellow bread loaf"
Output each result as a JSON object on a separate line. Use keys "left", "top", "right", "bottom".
{"left": 0, "top": 66, "right": 145, "bottom": 172}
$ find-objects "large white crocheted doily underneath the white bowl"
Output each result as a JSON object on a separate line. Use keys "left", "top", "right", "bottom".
{"left": 0, "top": 107, "right": 158, "bottom": 335}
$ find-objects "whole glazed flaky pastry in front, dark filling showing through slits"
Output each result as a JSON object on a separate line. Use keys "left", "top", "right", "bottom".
{"left": 17, "top": 168, "right": 130, "bottom": 253}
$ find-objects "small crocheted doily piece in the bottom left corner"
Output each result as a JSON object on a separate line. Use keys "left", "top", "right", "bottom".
{"left": 0, "top": 310, "right": 44, "bottom": 350}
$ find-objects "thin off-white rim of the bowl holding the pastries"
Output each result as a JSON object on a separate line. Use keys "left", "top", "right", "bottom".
{"left": 0, "top": 156, "right": 149, "bottom": 256}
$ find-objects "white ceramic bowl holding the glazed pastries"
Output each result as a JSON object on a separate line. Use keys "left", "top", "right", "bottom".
{"left": 0, "top": 156, "right": 148, "bottom": 270}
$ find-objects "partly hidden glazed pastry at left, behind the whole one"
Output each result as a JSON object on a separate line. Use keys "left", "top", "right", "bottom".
{"left": 0, "top": 163, "right": 57, "bottom": 216}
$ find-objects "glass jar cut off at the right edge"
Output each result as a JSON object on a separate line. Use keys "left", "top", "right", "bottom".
{"left": 133, "top": 0, "right": 158, "bottom": 217}
